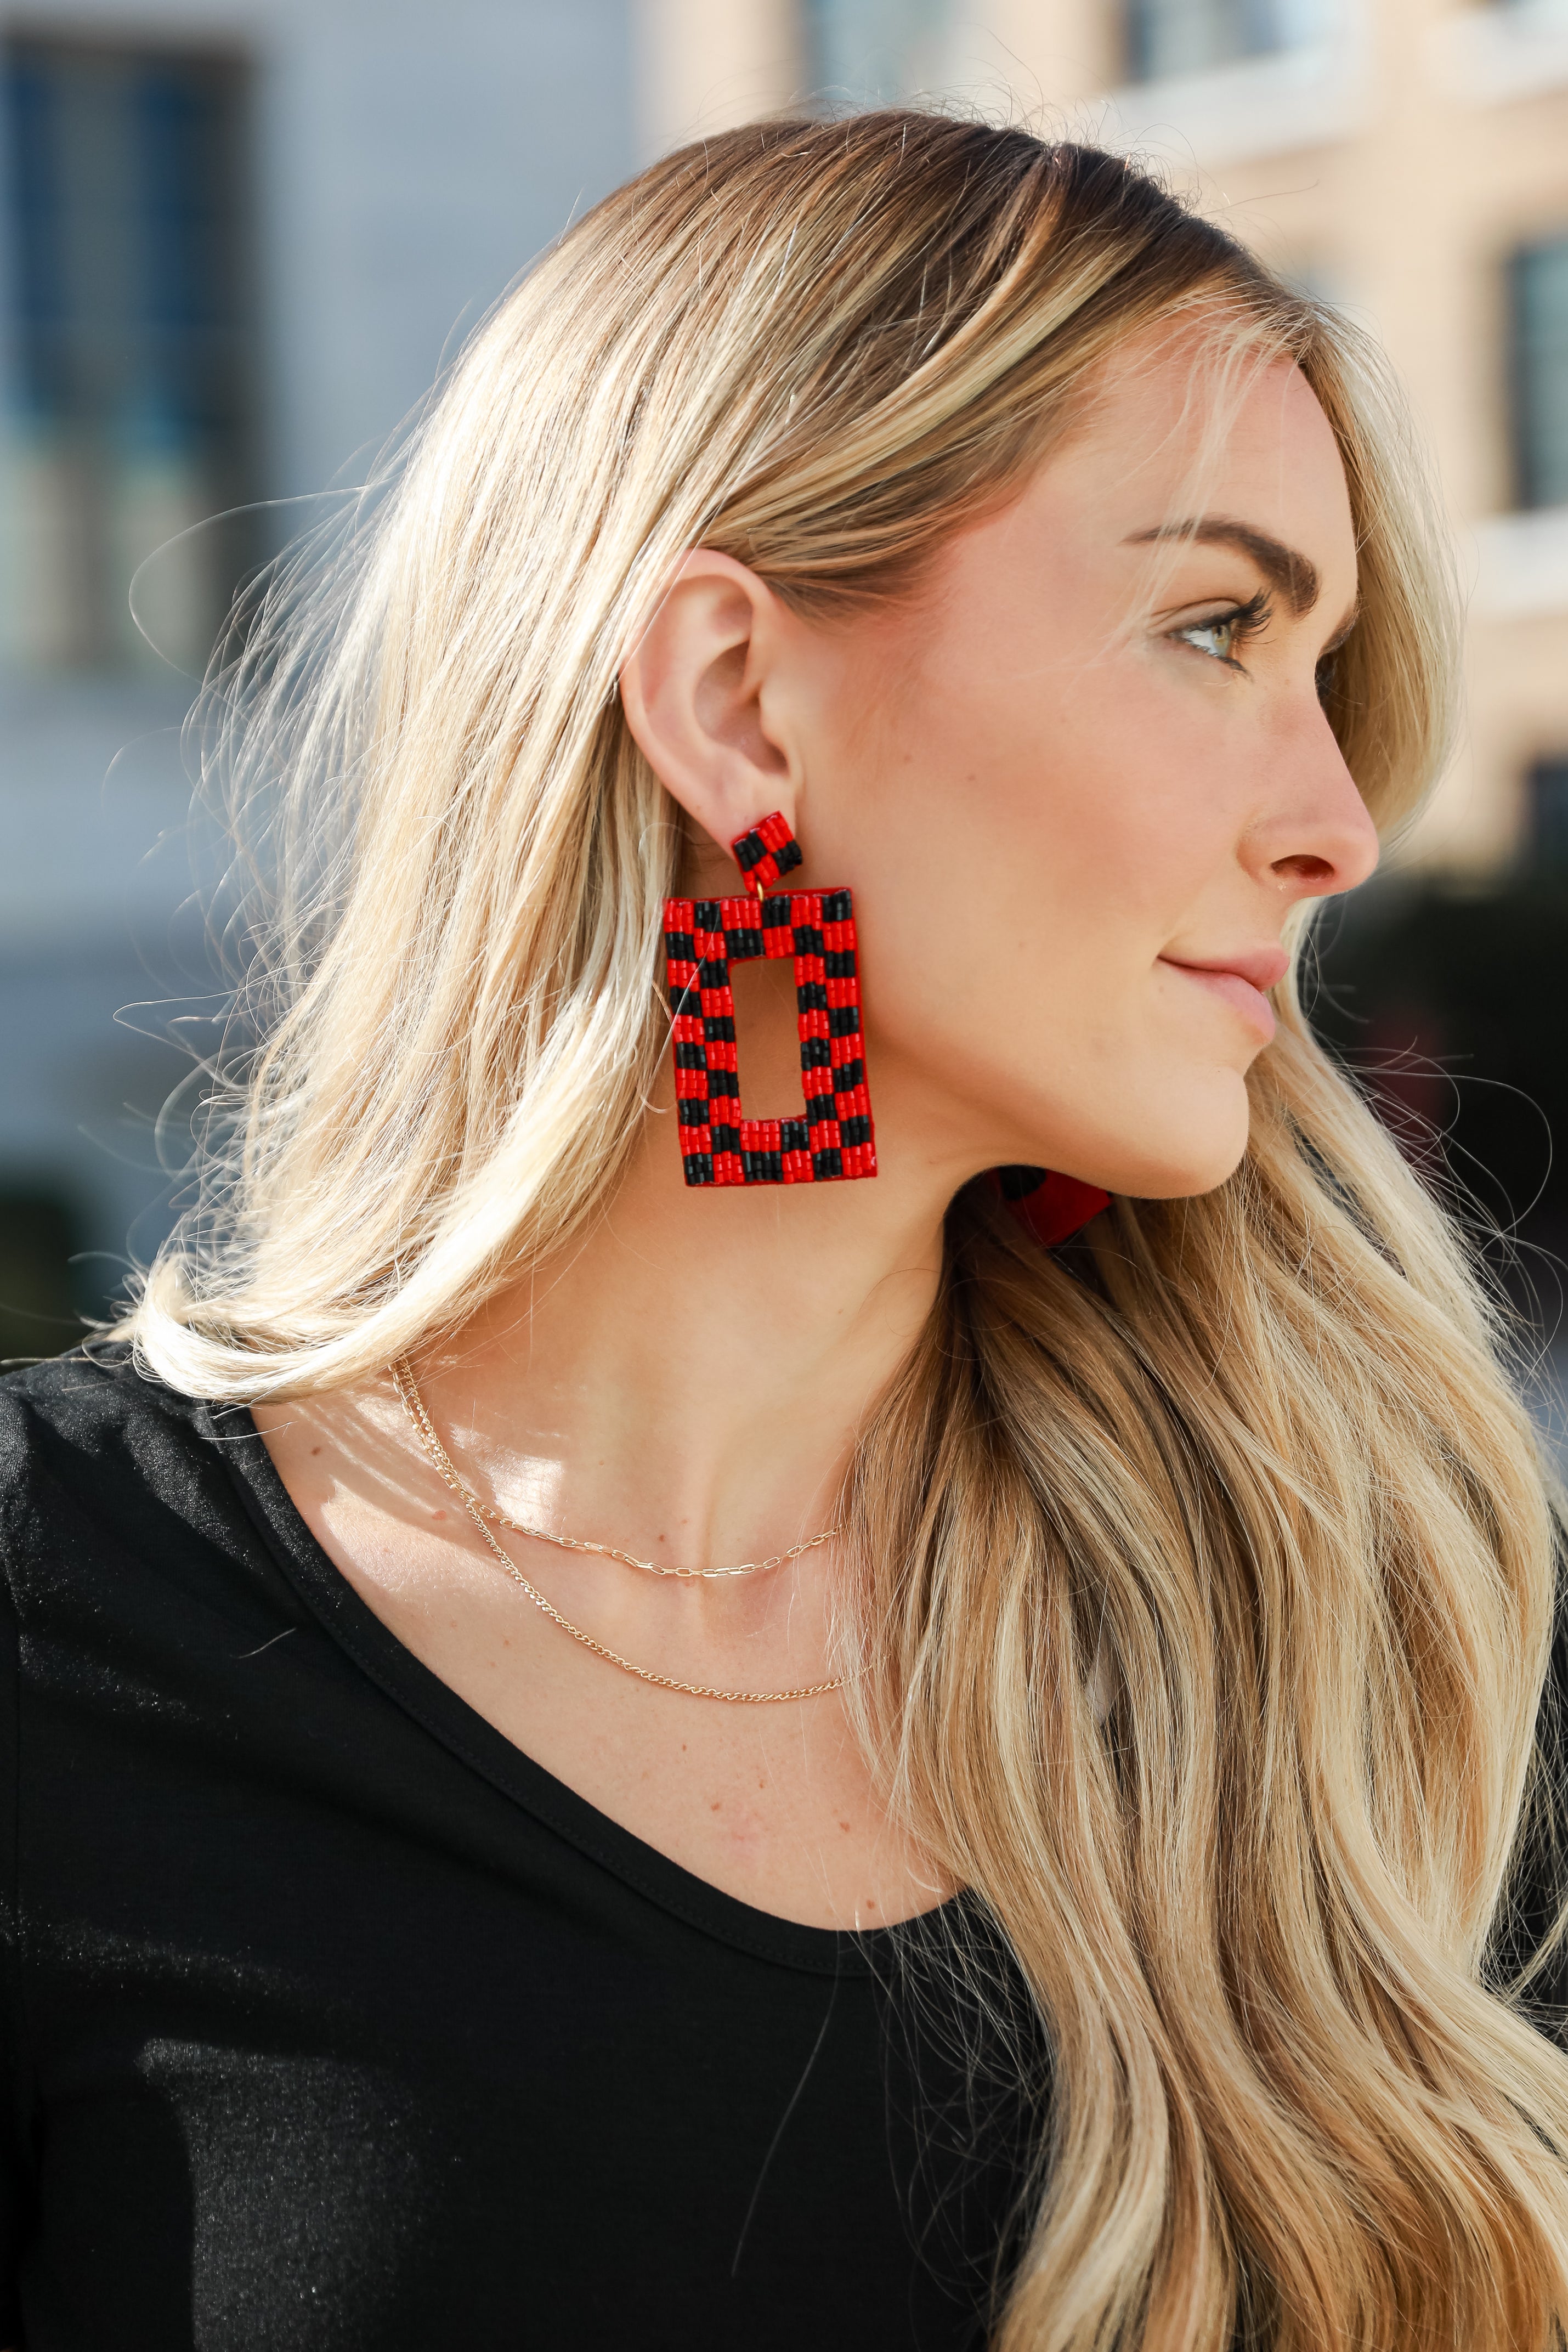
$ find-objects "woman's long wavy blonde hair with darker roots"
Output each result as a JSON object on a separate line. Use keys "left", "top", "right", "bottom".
{"left": 124, "top": 111, "right": 1568, "bottom": 2352}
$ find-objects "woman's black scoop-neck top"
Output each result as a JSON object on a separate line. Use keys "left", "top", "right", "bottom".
{"left": 0, "top": 1357, "right": 1044, "bottom": 2352}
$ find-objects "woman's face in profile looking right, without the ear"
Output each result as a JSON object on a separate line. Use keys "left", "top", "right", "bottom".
{"left": 785, "top": 338, "right": 1378, "bottom": 1197}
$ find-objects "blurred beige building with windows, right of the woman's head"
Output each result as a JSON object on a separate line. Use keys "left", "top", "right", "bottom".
{"left": 654, "top": 0, "right": 1568, "bottom": 882}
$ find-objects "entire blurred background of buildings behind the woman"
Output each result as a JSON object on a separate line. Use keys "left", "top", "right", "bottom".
{"left": 0, "top": 0, "right": 1568, "bottom": 1411}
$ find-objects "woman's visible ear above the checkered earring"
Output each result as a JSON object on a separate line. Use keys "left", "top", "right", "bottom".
{"left": 621, "top": 548, "right": 797, "bottom": 849}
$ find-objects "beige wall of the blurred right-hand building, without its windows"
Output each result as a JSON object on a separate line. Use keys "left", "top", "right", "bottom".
{"left": 644, "top": 0, "right": 1568, "bottom": 873}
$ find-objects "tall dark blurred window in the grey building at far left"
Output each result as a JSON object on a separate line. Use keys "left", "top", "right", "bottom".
{"left": 0, "top": 38, "right": 254, "bottom": 670}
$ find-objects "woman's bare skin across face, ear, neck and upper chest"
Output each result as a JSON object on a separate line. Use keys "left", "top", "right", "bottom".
{"left": 256, "top": 327, "right": 1378, "bottom": 1926}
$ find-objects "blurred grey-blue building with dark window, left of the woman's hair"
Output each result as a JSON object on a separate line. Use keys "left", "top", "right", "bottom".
{"left": 0, "top": 0, "right": 649, "bottom": 1355}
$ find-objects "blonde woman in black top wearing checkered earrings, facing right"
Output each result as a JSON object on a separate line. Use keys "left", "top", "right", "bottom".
{"left": 2, "top": 113, "right": 1568, "bottom": 2352}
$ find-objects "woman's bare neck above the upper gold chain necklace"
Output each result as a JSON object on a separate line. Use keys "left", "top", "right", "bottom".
{"left": 421, "top": 1091, "right": 947, "bottom": 1567}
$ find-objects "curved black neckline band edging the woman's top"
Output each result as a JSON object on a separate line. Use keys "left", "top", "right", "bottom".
{"left": 197, "top": 1404, "right": 964, "bottom": 1976}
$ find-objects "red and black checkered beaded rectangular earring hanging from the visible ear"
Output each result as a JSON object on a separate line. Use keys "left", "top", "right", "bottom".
{"left": 665, "top": 811, "right": 877, "bottom": 1183}
